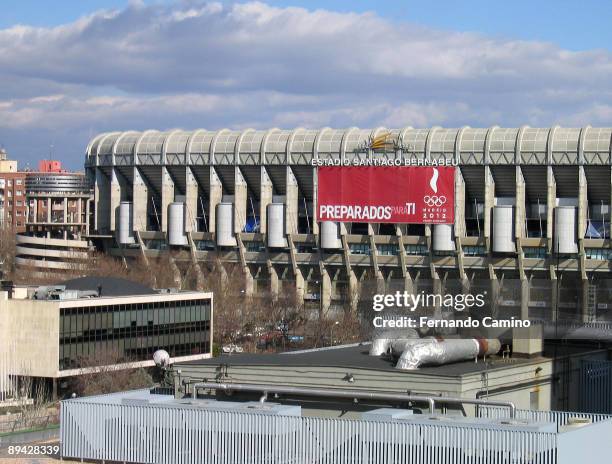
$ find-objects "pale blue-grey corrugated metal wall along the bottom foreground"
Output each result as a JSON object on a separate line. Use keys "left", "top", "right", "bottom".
{"left": 60, "top": 401, "right": 558, "bottom": 464}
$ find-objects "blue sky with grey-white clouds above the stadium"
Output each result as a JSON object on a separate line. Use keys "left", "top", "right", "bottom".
{"left": 0, "top": 0, "right": 612, "bottom": 169}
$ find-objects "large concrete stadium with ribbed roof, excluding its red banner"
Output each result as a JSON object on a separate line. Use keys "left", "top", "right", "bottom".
{"left": 85, "top": 127, "right": 612, "bottom": 321}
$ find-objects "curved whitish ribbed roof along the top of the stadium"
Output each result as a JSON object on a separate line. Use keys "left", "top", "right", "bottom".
{"left": 86, "top": 126, "right": 612, "bottom": 165}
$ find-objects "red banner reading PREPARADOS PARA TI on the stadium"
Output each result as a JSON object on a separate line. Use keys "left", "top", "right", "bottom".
{"left": 317, "top": 166, "right": 455, "bottom": 224}
